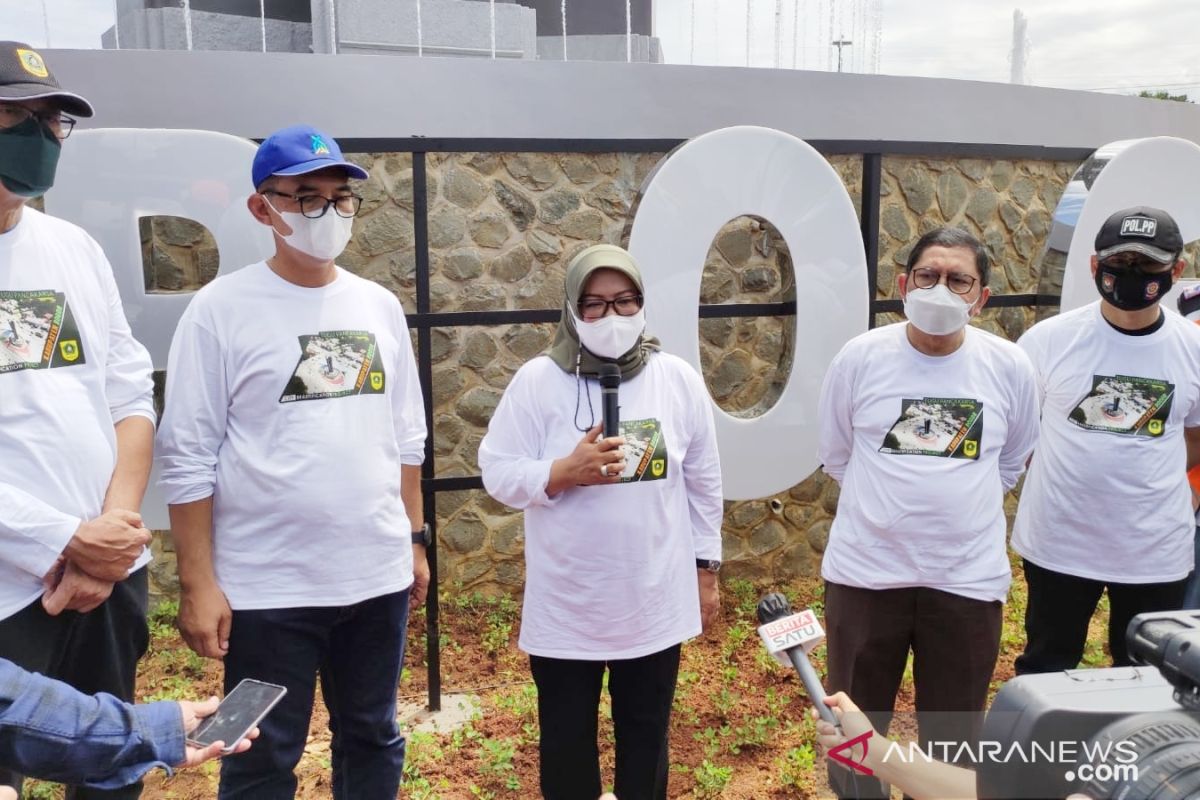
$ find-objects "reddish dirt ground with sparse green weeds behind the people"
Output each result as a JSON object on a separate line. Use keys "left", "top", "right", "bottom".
{"left": 21, "top": 563, "right": 1104, "bottom": 800}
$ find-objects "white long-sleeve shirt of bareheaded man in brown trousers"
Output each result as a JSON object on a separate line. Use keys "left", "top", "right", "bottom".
{"left": 818, "top": 323, "right": 1038, "bottom": 601}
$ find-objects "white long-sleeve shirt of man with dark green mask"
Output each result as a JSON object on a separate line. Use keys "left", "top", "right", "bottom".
{"left": 0, "top": 206, "right": 155, "bottom": 619}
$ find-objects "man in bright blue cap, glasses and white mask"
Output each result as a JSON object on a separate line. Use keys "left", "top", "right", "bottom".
{"left": 160, "top": 126, "right": 430, "bottom": 800}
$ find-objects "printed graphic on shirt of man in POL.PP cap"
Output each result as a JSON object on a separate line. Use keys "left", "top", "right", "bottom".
{"left": 1068, "top": 375, "right": 1175, "bottom": 438}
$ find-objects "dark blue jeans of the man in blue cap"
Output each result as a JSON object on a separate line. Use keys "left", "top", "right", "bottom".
{"left": 218, "top": 589, "right": 409, "bottom": 800}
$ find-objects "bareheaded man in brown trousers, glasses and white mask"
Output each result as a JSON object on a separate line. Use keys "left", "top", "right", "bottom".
{"left": 818, "top": 228, "right": 1037, "bottom": 798}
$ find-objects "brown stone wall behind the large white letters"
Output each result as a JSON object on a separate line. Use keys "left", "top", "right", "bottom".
{"left": 143, "top": 154, "right": 1078, "bottom": 593}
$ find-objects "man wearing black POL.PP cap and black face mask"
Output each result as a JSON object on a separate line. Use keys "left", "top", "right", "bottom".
{"left": 1013, "top": 206, "right": 1200, "bottom": 674}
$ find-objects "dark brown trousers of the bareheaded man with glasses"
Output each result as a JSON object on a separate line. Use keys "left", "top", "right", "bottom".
{"left": 824, "top": 582, "right": 1003, "bottom": 798}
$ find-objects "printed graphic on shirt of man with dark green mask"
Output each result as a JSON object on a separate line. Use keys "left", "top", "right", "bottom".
{"left": 0, "top": 289, "right": 86, "bottom": 374}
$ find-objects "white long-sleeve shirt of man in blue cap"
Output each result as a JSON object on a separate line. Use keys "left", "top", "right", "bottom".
{"left": 158, "top": 263, "right": 426, "bottom": 609}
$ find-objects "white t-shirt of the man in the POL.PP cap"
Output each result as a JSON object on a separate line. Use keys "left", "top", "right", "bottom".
{"left": 1013, "top": 301, "right": 1200, "bottom": 583}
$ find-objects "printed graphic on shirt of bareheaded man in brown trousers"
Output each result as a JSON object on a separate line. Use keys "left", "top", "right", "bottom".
{"left": 880, "top": 397, "right": 983, "bottom": 461}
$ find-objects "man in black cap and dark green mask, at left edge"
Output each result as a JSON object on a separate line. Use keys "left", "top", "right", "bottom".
{"left": 0, "top": 42, "right": 155, "bottom": 798}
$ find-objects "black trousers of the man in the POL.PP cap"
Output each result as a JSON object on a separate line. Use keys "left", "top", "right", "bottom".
{"left": 1015, "top": 560, "right": 1188, "bottom": 675}
